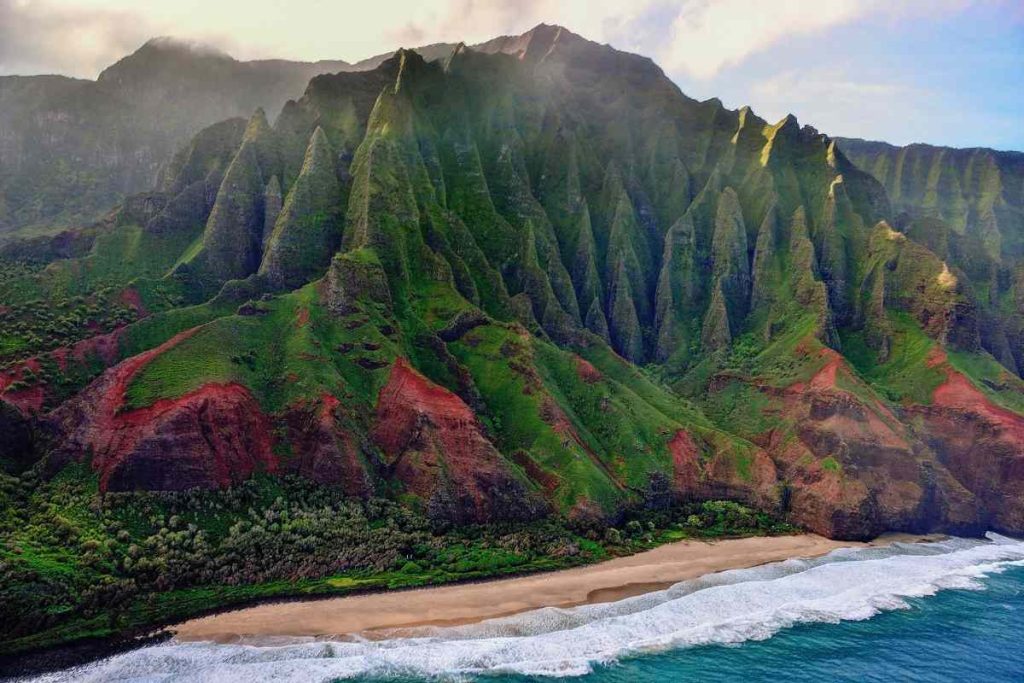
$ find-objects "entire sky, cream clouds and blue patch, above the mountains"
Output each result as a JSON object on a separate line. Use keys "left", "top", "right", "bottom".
{"left": 0, "top": 0, "right": 1024, "bottom": 151}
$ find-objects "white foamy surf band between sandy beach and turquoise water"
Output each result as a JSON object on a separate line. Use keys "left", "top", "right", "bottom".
{"left": 28, "top": 535, "right": 1024, "bottom": 683}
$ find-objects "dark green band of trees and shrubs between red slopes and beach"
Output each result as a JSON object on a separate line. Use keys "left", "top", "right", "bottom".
{"left": 0, "top": 466, "right": 794, "bottom": 654}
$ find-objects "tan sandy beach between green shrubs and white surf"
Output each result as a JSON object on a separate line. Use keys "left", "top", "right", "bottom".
{"left": 169, "top": 533, "right": 933, "bottom": 643}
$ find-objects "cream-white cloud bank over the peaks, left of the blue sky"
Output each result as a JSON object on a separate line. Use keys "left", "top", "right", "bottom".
{"left": 0, "top": 0, "right": 1013, "bottom": 91}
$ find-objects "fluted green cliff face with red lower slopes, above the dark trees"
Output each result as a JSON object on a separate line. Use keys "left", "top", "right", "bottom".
{"left": 0, "top": 26, "right": 1024, "bottom": 538}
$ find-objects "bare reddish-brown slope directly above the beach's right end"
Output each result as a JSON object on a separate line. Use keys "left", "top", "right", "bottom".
{"left": 758, "top": 348, "right": 978, "bottom": 538}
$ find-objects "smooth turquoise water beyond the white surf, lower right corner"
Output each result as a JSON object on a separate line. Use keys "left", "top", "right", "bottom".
{"left": 509, "top": 567, "right": 1024, "bottom": 683}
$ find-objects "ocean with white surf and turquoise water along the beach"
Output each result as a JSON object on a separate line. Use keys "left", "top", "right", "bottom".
{"left": 28, "top": 533, "right": 1024, "bottom": 683}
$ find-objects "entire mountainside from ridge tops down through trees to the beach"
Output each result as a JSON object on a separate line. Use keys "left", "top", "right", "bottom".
{"left": 0, "top": 25, "right": 1024, "bottom": 665}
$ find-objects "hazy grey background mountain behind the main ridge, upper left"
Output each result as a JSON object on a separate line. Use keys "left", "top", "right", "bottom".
{"left": 0, "top": 38, "right": 349, "bottom": 239}
